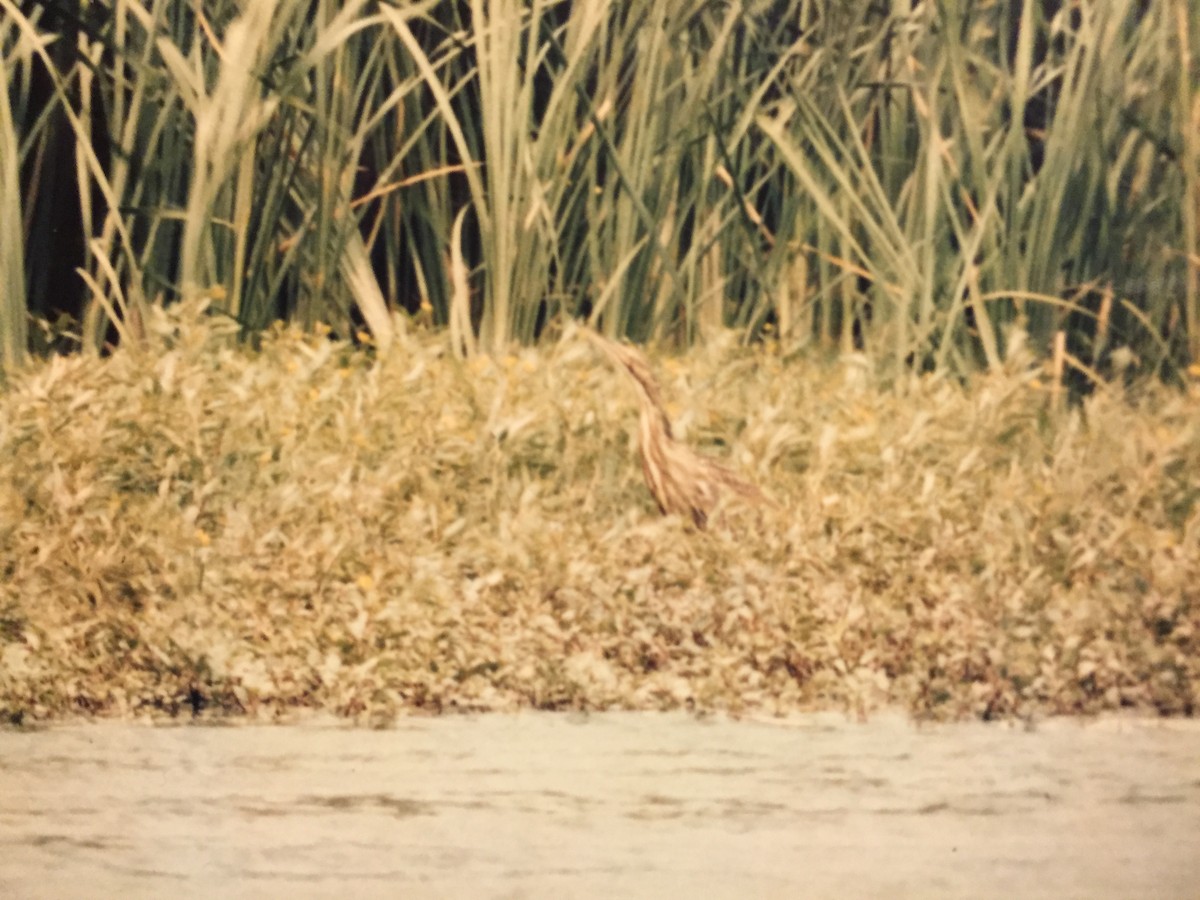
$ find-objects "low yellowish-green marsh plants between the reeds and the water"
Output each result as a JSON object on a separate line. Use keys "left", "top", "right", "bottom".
{"left": 0, "top": 303, "right": 1200, "bottom": 722}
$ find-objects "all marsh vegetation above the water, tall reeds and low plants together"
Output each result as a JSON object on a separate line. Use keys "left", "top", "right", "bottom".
{"left": 0, "top": 0, "right": 1200, "bottom": 720}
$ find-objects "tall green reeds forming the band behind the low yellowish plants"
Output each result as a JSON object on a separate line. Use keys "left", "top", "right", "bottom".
{"left": 0, "top": 0, "right": 1200, "bottom": 373}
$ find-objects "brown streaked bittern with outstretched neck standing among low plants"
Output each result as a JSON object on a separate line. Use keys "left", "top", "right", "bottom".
{"left": 583, "top": 329, "right": 764, "bottom": 528}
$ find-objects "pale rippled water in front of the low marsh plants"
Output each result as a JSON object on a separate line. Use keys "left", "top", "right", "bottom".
{"left": 0, "top": 713, "right": 1200, "bottom": 900}
